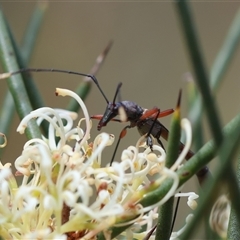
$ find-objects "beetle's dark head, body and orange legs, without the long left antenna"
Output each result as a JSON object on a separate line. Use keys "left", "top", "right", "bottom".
{"left": 91, "top": 83, "right": 174, "bottom": 165}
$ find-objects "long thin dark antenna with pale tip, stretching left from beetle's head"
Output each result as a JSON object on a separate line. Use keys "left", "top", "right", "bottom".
{"left": 0, "top": 68, "right": 109, "bottom": 103}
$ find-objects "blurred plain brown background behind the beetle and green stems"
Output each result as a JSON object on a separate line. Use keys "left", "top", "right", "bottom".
{"left": 0, "top": 1, "right": 240, "bottom": 237}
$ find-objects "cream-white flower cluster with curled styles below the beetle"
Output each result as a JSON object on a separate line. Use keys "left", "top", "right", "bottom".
{"left": 0, "top": 89, "right": 197, "bottom": 239}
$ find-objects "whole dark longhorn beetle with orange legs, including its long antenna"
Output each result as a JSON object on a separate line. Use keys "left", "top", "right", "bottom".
{"left": 0, "top": 68, "right": 208, "bottom": 183}
